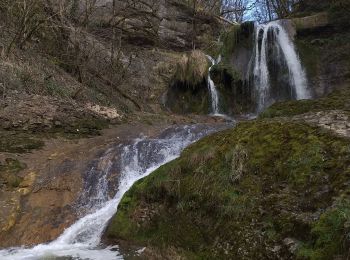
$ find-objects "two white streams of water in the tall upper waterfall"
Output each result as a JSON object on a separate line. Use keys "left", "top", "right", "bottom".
{"left": 253, "top": 21, "right": 311, "bottom": 112}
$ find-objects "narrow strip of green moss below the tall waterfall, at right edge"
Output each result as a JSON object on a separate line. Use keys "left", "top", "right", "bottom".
{"left": 259, "top": 89, "right": 350, "bottom": 118}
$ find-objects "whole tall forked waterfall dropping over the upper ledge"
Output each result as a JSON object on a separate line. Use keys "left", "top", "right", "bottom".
{"left": 248, "top": 21, "right": 311, "bottom": 112}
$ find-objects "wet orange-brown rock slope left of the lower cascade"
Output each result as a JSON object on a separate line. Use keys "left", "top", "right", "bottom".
{"left": 0, "top": 112, "right": 231, "bottom": 259}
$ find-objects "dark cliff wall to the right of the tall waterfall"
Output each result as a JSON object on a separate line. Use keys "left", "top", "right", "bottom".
{"left": 293, "top": 13, "right": 350, "bottom": 97}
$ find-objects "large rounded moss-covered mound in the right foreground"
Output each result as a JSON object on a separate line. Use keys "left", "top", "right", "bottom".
{"left": 106, "top": 120, "right": 350, "bottom": 259}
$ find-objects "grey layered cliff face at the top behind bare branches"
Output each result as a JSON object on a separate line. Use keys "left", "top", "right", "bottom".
{"left": 90, "top": 0, "right": 221, "bottom": 51}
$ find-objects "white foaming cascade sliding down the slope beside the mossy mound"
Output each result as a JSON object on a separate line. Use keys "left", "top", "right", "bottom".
{"left": 0, "top": 125, "right": 227, "bottom": 260}
